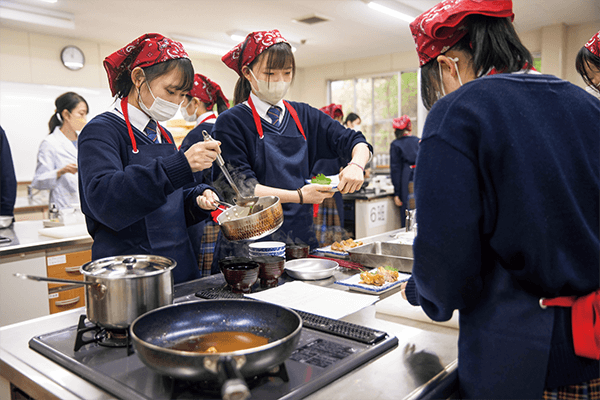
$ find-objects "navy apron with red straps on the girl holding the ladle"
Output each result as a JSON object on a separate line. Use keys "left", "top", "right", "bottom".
{"left": 121, "top": 97, "right": 200, "bottom": 283}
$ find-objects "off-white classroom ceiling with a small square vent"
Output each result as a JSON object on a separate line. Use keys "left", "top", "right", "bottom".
{"left": 0, "top": 0, "right": 600, "bottom": 67}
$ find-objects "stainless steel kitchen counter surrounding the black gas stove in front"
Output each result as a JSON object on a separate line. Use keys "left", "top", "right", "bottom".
{"left": 0, "top": 270, "right": 458, "bottom": 400}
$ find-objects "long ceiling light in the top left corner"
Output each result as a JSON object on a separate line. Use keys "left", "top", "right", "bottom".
{"left": 0, "top": 1, "right": 75, "bottom": 29}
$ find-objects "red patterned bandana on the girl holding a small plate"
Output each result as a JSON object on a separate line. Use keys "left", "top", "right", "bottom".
{"left": 221, "top": 29, "right": 288, "bottom": 76}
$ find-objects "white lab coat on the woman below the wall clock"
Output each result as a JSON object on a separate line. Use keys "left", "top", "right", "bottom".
{"left": 31, "top": 127, "right": 79, "bottom": 210}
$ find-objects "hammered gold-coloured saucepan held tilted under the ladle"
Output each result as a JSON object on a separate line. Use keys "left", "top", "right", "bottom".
{"left": 217, "top": 196, "right": 283, "bottom": 241}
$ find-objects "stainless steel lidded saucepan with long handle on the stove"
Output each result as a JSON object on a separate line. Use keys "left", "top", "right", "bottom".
{"left": 15, "top": 255, "right": 177, "bottom": 329}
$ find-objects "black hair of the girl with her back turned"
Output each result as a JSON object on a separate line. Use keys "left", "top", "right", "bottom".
{"left": 421, "top": 14, "right": 533, "bottom": 110}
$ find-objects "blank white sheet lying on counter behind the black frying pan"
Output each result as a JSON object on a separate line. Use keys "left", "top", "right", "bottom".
{"left": 244, "top": 281, "right": 379, "bottom": 319}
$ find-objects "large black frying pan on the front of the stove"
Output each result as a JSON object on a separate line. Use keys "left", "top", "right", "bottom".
{"left": 130, "top": 300, "right": 302, "bottom": 399}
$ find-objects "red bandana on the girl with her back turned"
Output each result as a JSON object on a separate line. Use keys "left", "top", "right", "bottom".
{"left": 410, "top": 0, "right": 515, "bottom": 66}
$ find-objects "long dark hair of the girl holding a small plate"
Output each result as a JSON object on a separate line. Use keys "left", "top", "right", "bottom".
{"left": 233, "top": 39, "right": 296, "bottom": 105}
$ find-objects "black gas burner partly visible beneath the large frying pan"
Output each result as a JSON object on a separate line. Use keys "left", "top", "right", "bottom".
{"left": 168, "top": 363, "right": 290, "bottom": 400}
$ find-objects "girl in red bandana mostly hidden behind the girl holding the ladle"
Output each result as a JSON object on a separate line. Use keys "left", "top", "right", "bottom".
{"left": 180, "top": 74, "right": 229, "bottom": 276}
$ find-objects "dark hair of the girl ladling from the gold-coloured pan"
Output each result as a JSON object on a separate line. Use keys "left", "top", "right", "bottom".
{"left": 115, "top": 58, "right": 194, "bottom": 99}
